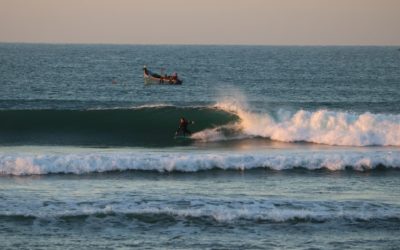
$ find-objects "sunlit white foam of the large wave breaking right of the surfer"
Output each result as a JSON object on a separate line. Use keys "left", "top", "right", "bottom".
{"left": 205, "top": 101, "right": 400, "bottom": 146}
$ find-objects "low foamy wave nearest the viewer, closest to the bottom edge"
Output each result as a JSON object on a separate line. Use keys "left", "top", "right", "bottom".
{"left": 0, "top": 200, "right": 400, "bottom": 223}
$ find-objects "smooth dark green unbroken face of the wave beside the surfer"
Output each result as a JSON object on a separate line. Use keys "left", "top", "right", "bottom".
{"left": 0, "top": 105, "right": 237, "bottom": 146}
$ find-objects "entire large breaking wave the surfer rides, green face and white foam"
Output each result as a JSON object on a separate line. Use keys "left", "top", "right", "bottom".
{"left": 0, "top": 100, "right": 400, "bottom": 147}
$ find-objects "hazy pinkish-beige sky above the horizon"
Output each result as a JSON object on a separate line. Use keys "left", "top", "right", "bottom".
{"left": 0, "top": 0, "right": 400, "bottom": 45}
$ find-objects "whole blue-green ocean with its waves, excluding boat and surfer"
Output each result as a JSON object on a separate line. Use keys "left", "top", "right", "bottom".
{"left": 0, "top": 43, "right": 400, "bottom": 249}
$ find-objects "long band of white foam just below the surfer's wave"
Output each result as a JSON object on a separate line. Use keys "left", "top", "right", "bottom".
{"left": 0, "top": 150, "right": 400, "bottom": 175}
